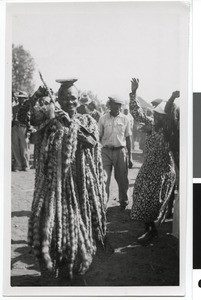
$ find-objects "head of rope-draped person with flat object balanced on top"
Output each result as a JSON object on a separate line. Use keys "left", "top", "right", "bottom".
{"left": 56, "top": 79, "right": 79, "bottom": 117}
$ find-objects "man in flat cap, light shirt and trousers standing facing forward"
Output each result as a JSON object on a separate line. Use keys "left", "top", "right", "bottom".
{"left": 99, "top": 96, "right": 133, "bottom": 210}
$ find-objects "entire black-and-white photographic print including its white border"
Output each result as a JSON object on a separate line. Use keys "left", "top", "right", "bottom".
{"left": 4, "top": 1, "right": 191, "bottom": 296}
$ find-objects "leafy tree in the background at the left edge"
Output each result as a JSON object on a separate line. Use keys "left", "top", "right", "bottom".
{"left": 12, "top": 44, "right": 35, "bottom": 94}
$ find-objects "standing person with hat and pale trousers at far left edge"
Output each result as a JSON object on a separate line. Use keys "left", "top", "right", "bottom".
{"left": 12, "top": 92, "right": 30, "bottom": 172}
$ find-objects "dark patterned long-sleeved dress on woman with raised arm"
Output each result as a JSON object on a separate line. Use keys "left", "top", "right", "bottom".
{"left": 130, "top": 94, "right": 175, "bottom": 223}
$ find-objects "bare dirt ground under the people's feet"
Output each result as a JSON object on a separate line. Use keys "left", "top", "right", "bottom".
{"left": 11, "top": 152, "right": 179, "bottom": 286}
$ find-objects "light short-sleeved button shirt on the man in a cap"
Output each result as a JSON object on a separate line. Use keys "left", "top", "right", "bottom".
{"left": 98, "top": 113, "right": 132, "bottom": 147}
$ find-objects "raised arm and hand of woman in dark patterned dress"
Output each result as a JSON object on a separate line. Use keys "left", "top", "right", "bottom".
{"left": 130, "top": 78, "right": 153, "bottom": 125}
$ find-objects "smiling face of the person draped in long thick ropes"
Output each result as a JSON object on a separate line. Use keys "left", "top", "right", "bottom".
{"left": 59, "top": 86, "right": 78, "bottom": 116}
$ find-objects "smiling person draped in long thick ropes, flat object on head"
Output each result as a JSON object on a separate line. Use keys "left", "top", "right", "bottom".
{"left": 28, "top": 80, "right": 106, "bottom": 284}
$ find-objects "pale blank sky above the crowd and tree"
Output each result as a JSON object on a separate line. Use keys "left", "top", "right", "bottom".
{"left": 8, "top": 2, "right": 188, "bottom": 102}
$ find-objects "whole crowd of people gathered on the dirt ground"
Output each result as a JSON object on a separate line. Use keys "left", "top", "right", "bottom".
{"left": 12, "top": 78, "right": 180, "bottom": 284}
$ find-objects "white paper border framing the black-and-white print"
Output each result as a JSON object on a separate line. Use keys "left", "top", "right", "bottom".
{"left": 2, "top": 1, "right": 192, "bottom": 299}
